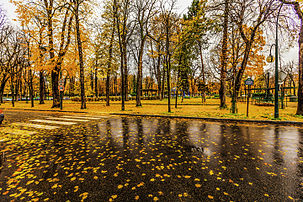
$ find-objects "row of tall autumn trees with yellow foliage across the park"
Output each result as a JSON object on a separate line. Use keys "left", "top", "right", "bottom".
{"left": 0, "top": 0, "right": 303, "bottom": 115}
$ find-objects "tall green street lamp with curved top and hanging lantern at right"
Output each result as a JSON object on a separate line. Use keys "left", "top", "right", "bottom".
{"left": 267, "top": 3, "right": 283, "bottom": 119}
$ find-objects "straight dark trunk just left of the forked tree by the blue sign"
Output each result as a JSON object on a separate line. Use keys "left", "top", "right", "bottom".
{"left": 219, "top": 0, "right": 229, "bottom": 108}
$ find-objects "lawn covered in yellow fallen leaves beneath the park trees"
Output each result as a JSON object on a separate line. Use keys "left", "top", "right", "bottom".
{"left": 0, "top": 98, "right": 303, "bottom": 121}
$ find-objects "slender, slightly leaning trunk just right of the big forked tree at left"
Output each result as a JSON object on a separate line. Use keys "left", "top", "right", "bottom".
{"left": 75, "top": 8, "right": 86, "bottom": 109}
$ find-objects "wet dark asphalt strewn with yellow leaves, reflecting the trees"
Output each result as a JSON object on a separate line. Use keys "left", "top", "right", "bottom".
{"left": 0, "top": 117, "right": 303, "bottom": 201}
